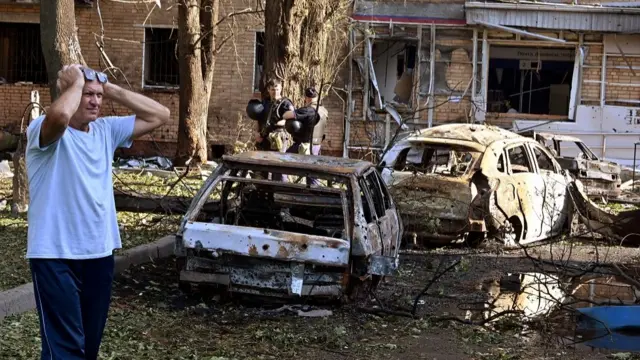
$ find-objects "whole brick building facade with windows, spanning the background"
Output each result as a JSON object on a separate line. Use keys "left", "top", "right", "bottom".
{"left": 0, "top": 0, "right": 640, "bottom": 163}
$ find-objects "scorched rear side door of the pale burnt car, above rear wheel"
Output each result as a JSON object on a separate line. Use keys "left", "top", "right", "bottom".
{"left": 505, "top": 143, "right": 546, "bottom": 243}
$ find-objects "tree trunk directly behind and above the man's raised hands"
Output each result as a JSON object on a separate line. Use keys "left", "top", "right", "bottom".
{"left": 40, "top": 0, "right": 86, "bottom": 102}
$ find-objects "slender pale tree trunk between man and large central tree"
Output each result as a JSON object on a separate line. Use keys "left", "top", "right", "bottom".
{"left": 174, "top": 0, "right": 219, "bottom": 166}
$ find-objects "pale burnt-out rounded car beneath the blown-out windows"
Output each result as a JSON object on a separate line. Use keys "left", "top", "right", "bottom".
{"left": 380, "top": 124, "right": 572, "bottom": 246}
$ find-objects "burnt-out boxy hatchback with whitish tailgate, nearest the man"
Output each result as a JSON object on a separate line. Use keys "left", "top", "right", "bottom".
{"left": 176, "top": 151, "right": 403, "bottom": 297}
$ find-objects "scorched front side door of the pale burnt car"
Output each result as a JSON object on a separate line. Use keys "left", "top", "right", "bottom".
{"left": 529, "top": 143, "right": 568, "bottom": 237}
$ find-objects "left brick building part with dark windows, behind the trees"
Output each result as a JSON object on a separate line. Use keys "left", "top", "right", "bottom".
{"left": 0, "top": 0, "right": 343, "bottom": 157}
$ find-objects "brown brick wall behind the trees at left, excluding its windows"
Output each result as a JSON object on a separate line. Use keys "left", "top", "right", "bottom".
{"left": 0, "top": 0, "right": 352, "bottom": 156}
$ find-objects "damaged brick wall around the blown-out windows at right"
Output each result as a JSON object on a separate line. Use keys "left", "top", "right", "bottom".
{"left": 350, "top": 9, "right": 640, "bottom": 158}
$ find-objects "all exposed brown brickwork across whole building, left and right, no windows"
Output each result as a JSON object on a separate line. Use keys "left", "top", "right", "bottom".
{"left": 0, "top": 0, "right": 640, "bottom": 160}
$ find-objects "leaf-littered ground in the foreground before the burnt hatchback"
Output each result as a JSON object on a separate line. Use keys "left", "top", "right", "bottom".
{"left": 0, "top": 253, "right": 620, "bottom": 360}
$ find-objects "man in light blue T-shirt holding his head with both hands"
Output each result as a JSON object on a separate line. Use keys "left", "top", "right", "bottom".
{"left": 26, "top": 64, "right": 170, "bottom": 360}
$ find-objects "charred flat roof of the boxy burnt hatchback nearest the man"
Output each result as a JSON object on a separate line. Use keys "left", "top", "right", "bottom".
{"left": 222, "top": 151, "right": 374, "bottom": 175}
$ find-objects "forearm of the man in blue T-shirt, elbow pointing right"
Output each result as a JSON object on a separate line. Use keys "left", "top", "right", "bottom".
{"left": 104, "top": 83, "right": 169, "bottom": 123}
